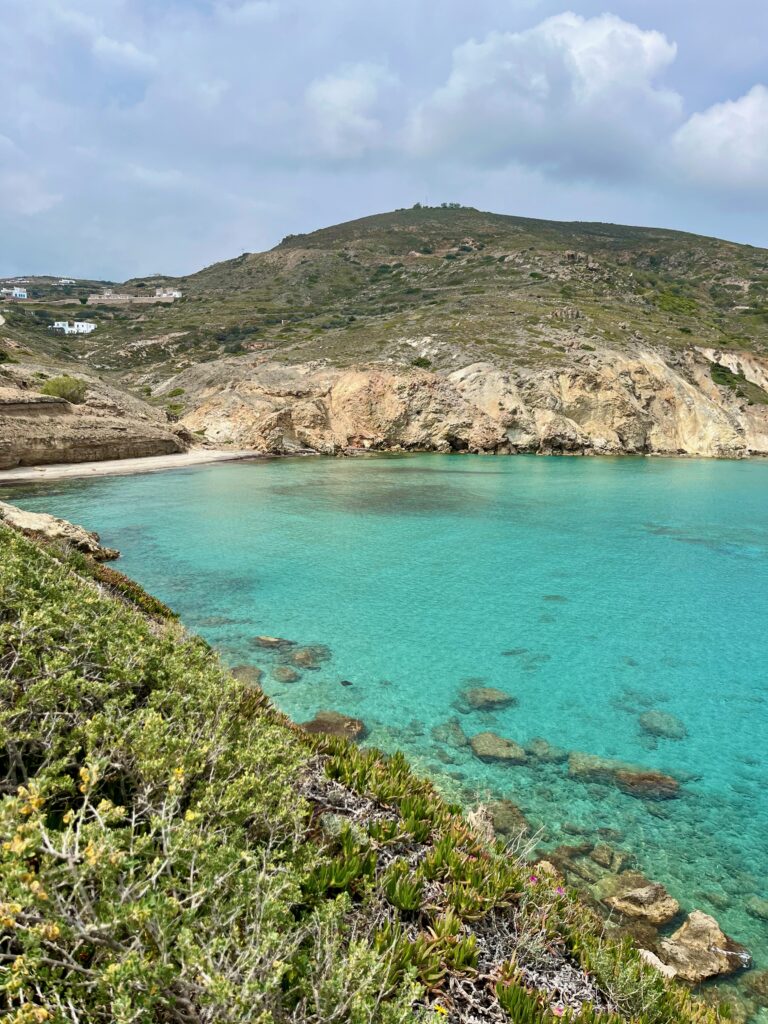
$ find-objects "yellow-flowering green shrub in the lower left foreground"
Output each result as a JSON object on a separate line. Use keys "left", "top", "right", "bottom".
{"left": 0, "top": 526, "right": 420, "bottom": 1024}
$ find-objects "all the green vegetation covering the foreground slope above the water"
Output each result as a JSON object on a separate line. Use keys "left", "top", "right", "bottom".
{"left": 0, "top": 526, "right": 733, "bottom": 1024}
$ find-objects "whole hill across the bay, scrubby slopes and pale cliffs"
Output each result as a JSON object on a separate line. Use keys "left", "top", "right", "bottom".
{"left": 0, "top": 209, "right": 768, "bottom": 464}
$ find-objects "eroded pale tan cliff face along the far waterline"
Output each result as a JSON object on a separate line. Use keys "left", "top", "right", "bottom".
{"left": 178, "top": 349, "right": 768, "bottom": 458}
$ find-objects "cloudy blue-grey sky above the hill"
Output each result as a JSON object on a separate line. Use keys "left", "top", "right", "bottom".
{"left": 0, "top": 0, "right": 768, "bottom": 281}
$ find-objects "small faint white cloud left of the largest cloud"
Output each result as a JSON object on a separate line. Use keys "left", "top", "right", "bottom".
{"left": 304, "top": 63, "right": 394, "bottom": 159}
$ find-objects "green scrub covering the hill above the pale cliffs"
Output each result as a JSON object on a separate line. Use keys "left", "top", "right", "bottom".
{"left": 4, "top": 203, "right": 768, "bottom": 387}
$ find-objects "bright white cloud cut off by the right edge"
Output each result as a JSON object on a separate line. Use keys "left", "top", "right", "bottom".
{"left": 673, "top": 85, "right": 768, "bottom": 196}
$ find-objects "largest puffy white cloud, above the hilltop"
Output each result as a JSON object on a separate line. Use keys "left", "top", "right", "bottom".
{"left": 406, "top": 13, "right": 682, "bottom": 179}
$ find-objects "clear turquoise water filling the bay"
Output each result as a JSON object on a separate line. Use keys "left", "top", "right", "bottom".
{"left": 4, "top": 456, "right": 768, "bottom": 1007}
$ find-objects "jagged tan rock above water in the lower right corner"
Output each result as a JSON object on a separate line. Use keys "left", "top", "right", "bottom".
{"left": 659, "top": 910, "right": 752, "bottom": 985}
